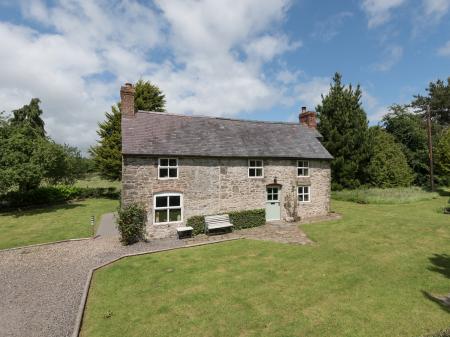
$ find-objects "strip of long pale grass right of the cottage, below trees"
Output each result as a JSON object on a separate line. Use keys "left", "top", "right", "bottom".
{"left": 331, "top": 187, "right": 439, "bottom": 204}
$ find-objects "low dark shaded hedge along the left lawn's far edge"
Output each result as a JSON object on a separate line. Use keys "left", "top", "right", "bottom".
{"left": 0, "top": 185, "right": 120, "bottom": 209}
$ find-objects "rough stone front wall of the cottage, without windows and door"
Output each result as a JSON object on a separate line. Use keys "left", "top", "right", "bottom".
{"left": 122, "top": 156, "right": 331, "bottom": 238}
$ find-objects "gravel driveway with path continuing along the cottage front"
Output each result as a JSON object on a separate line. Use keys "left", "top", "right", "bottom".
{"left": 0, "top": 217, "right": 326, "bottom": 337}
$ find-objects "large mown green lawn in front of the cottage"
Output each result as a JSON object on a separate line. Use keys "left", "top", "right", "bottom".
{"left": 81, "top": 197, "right": 450, "bottom": 337}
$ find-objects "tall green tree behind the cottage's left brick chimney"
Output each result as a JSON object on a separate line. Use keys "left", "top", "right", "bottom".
{"left": 89, "top": 80, "right": 166, "bottom": 180}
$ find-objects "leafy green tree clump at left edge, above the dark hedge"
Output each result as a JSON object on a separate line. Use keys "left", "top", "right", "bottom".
{"left": 0, "top": 98, "right": 87, "bottom": 194}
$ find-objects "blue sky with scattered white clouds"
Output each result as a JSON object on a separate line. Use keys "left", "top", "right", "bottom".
{"left": 0, "top": 0, "right": 450, "bottom": 152}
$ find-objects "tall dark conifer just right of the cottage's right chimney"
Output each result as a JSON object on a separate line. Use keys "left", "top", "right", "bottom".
{"left": 316, "top": 73, "right": 370, "bottom": 189}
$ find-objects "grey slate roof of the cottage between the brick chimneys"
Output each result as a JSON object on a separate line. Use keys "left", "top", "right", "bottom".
{"left": 122, "top": 111, "right": 332, "bottom": 159}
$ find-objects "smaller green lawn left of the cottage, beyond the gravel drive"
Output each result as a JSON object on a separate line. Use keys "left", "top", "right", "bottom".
{"left": 0, "top": 199, "right": 118, "bottom": 249}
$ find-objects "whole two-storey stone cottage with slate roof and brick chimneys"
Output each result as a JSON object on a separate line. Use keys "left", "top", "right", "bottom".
{"left": 121, "top": 84, "right": 332, "bottom": 238}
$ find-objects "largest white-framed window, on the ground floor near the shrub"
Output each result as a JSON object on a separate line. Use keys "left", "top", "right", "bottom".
{"left": 153, "top": 193, "right": 183, "bottom": 224}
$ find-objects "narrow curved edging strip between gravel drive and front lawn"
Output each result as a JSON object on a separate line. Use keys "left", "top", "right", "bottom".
{"left": 72, "top": 238, "right": 245, "bottom": 337}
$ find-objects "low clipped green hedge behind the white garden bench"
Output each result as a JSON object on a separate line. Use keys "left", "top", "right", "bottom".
{"left": 186, "top": 209, "right": 266, "bottom": 235}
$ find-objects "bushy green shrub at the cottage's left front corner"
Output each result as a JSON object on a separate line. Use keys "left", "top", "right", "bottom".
{"left": 117, "top": 204, "right": 145, "bottom": 245}
